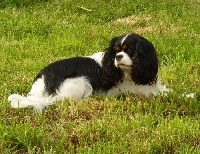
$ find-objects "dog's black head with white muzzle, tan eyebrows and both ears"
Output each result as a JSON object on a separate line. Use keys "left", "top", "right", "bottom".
{"left": 102, "top": 33, "right": 158, "bottom": 86}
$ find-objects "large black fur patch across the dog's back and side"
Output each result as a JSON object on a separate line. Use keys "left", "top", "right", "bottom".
{"left": 34, "top": 57, "right": 103, "bottom": 95}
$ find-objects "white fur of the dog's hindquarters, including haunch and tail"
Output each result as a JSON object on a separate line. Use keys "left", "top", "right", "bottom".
{"left": 8, "top": 77, "right": 92, "bottom": 112}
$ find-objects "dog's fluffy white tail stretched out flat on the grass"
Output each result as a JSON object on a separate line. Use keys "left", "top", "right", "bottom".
{"left": 8, "top": 94, "right": 56, "bottom": 112}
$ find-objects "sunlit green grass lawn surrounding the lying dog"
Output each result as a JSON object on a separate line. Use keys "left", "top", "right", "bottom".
{"left": 0, "top": 0, "right": 200, "bottom": 154}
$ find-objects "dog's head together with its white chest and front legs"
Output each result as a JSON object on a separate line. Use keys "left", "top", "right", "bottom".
{"left": 102, "top": 33, "right": 170, "bottom": 97}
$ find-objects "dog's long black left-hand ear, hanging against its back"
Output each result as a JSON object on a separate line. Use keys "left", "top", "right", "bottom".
{"left": 102, "top": 37, "right": 123, "bottom": 89}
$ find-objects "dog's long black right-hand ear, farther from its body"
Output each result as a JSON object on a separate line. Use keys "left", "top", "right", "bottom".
{"left": 131, "top": 38, "right": 158, "bottom": 85}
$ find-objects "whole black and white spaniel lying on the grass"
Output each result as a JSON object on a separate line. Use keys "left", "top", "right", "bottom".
{"left": 8, "top": 33, "right": 169, "bottom": 111}
